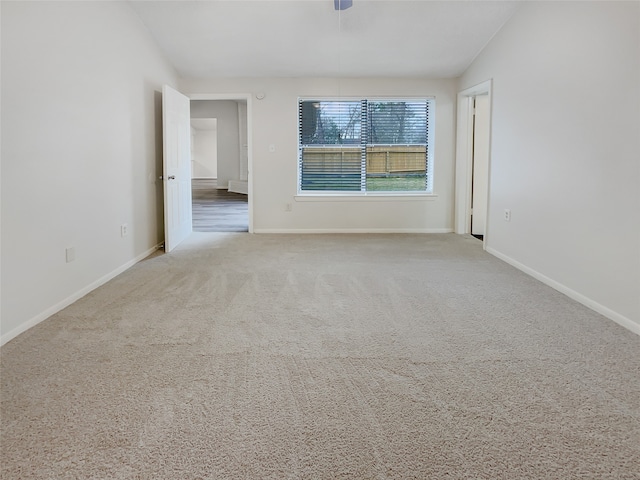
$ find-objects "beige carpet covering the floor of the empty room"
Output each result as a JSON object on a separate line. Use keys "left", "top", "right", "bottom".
{"left": 0, "top": 233, "right": 640, "bottom": 479}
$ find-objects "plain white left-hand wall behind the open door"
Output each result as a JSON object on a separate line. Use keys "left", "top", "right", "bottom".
{"left": 0, "top": 2, "right": 177, "bottom": 342}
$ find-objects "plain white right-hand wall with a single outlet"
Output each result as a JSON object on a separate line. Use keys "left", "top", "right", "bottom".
{"left": 459, "top": 2, "right": 640, "bottom": 333}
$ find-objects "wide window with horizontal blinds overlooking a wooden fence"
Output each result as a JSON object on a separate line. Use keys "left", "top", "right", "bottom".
{"left": 298, "top": 99, "right": 433, "bottom": 194}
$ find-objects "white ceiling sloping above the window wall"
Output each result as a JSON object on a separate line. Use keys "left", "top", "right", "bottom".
{"left": 130, "top": 0, "right": 521, "bottom": 78}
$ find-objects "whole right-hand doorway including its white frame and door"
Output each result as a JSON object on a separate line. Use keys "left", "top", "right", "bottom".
{"left": 454, "top": 80, "right": 491, "bottom": 248}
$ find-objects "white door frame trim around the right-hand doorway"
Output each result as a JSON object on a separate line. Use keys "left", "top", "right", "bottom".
{"left": 454, "top": 80, "right": 493, "bottom": 248}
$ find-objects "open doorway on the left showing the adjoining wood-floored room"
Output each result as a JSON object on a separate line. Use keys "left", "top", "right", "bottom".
{"left": 191, "top": 98, "right": 249, "bottom": 232}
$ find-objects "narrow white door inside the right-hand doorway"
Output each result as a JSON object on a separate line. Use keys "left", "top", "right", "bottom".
{"left": 471, "top": 95, "right": 489, "bottom": 235}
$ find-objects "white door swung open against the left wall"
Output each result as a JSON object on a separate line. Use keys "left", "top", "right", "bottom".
{"left": 162, "top": 85, "right": 192, "bottom": 252}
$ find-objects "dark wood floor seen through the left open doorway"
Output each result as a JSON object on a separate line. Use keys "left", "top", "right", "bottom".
{"left": 191, "top": 179, "right": 249, "bottom": 232}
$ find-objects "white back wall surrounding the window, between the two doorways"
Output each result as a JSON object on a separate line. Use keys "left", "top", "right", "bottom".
{"left": 180, "top": 78, "right": 456, "bottom": 232}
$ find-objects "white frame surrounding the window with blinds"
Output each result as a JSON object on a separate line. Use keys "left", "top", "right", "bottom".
{"left": 296, "top": 95, "right": 437, "bottom": 196}
